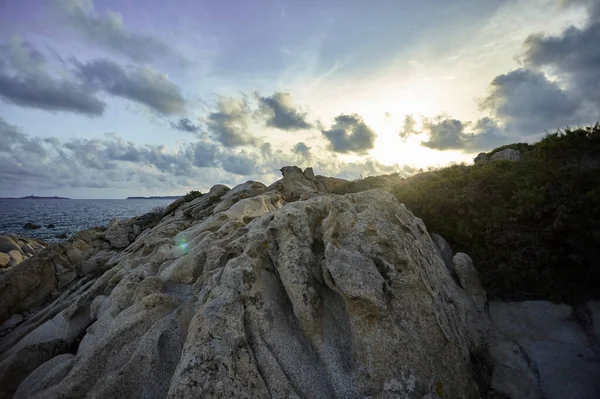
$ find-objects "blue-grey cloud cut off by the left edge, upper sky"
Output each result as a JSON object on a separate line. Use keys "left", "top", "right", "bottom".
{"left": 0, "top": 36, "right": 106, "bottom": 116}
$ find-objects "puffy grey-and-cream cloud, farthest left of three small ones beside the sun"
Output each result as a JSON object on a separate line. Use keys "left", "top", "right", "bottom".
{"left": 206, "top": 98, "right": 256, "bottom": 148}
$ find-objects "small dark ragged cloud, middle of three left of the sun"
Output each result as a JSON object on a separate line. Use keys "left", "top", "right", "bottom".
{"left": 256, "top": 92, "right": 312, "bottom": 130}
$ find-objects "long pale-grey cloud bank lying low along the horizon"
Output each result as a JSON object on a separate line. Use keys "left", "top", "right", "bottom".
{"left": 0, "top": 118, "right": 422, "bottom": 196}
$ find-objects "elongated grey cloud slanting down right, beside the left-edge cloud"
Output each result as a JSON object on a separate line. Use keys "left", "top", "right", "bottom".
{"left": 73, "top": 59, "right": 185, "bottom": 114}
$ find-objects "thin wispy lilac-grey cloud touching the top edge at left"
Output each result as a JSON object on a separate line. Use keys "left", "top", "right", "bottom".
{"left": 56, "top": 0, "right": 176, "bottom": 61}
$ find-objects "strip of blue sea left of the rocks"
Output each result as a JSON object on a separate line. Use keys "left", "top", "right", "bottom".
{"left": 0, "top": 199, "right": 174, "bottom": 242}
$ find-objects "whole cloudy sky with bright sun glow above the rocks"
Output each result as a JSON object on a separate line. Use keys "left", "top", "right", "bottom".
{"left": 0, "top": 0, "right": 600, "bottom": 198}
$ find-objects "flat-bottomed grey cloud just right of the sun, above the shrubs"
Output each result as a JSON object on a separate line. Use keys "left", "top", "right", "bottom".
{"left": 422, "top": 117, "right": 510, "bottom": 152}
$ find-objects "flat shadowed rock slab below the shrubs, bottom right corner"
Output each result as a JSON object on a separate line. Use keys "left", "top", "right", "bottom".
{"left": 488, "top": 301, "right": 600, "bottom": 399}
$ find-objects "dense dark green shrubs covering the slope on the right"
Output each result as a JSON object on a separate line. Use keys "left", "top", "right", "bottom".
{"left": 384, "top": 124, "right": 600, "bottom": 302}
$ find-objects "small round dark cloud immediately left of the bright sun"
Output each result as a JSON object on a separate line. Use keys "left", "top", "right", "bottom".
{"left": 321, "top": 114, "right": 377, "bottom": 154}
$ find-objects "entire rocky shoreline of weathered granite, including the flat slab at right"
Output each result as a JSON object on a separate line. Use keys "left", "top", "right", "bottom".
{"left": 0, "top": 166, "right": 600, "bottom": 399}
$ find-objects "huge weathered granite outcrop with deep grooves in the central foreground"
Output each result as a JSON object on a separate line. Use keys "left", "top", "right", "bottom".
{"left": 0, "top": 170, "right": 487, "bottom": 398}
